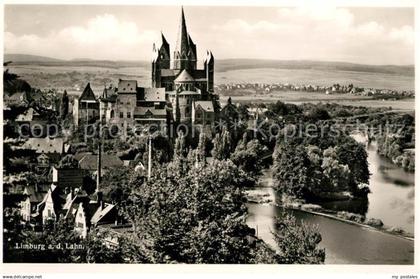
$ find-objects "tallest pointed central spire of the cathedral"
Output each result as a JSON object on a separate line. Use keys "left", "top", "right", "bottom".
{"left": 173, "top": 8, "right": 197, "bottom": 70}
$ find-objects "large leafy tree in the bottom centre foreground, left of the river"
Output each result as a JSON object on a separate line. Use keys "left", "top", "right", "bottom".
{"left": 123, "top": 160, "right": 255, "bottom": 263}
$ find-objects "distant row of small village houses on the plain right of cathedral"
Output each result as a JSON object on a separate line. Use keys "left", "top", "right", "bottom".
{"left": 214, "top": 83, "right": 414, "bottom": 98}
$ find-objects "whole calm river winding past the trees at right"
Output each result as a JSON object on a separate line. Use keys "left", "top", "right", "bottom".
{"left": 247, "top": 140, "right": 414, "bottom": 264}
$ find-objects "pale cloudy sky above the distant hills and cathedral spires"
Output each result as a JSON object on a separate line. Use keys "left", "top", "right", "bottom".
{"left": 4, "top": 5, "right": 414, "bottom": 65}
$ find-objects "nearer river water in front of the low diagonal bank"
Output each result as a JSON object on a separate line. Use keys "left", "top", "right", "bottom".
{"left": 247, "top": 199, "right": 414, "bottom": 264}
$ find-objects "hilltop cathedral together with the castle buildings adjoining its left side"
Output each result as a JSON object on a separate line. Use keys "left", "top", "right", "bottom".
{"left": 73, "top": 6, "right": 219, "bottom": 129}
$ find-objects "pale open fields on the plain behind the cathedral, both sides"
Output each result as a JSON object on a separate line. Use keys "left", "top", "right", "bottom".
{"left": 4, "top": 56, "right": 414, "bottom": 110}
